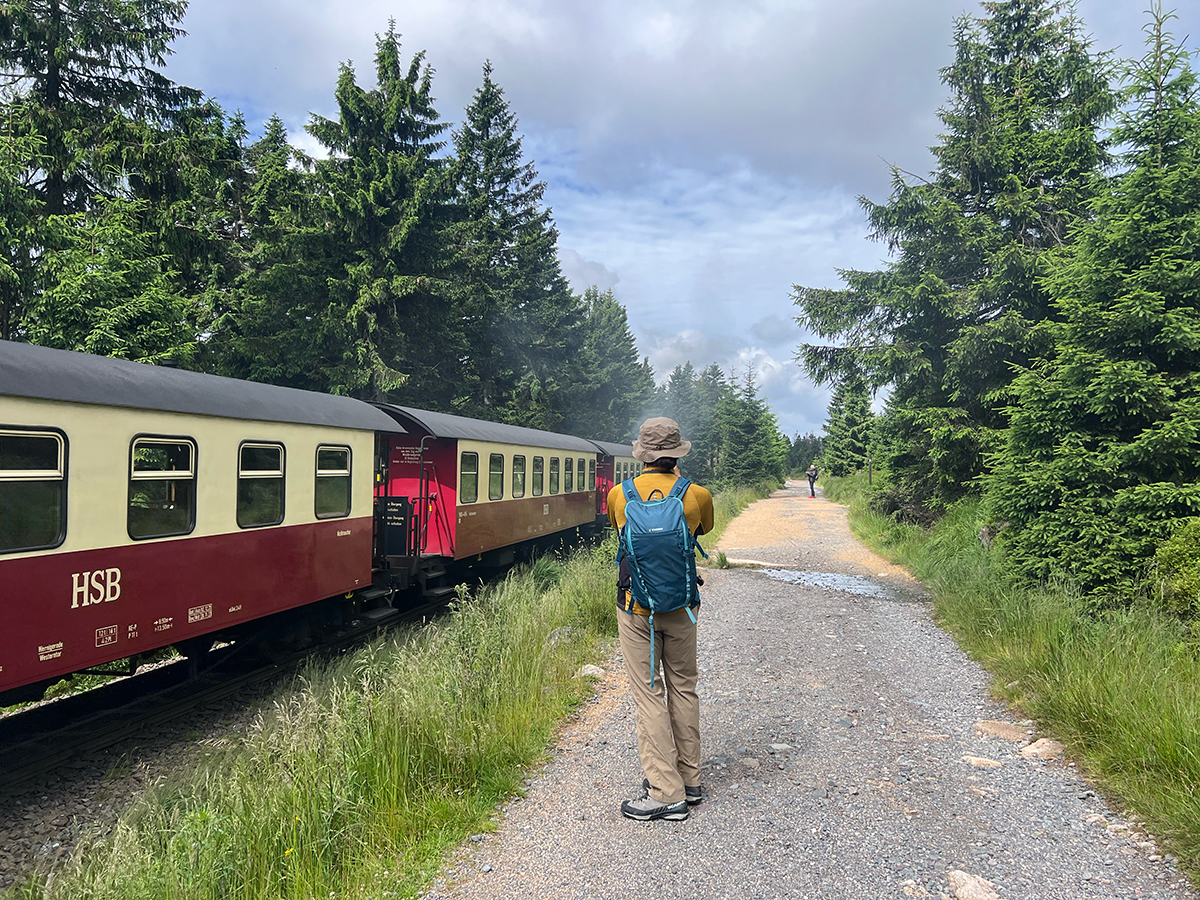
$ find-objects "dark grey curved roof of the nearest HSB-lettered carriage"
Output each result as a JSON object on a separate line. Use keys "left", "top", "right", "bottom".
{"left": 0, "top": 341, "right": 403, "bottom": 432}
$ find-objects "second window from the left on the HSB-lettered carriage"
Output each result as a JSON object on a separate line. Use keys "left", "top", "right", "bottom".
{"left": 126, "top": 438, "right": 196, "bottom": 540}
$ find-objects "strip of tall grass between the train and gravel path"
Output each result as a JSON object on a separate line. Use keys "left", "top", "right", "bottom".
{"left": 12, "top": 548, "right": 616, "bottom": 900}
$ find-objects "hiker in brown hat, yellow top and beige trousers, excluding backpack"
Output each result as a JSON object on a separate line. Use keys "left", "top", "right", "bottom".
{"left": 608, "top": 418, "right": 713, "bottom": 820}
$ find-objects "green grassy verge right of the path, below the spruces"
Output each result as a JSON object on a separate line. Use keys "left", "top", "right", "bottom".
{"left": 823, "top": 479, "right": 1200, "bottom": 881}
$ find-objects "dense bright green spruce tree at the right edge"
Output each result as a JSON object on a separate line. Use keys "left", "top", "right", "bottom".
{"left": 986, "top": 8, "right": 1200, "bottom": 598}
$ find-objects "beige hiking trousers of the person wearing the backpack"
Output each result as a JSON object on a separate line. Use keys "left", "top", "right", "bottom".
{"left": 617, "top": 610, "right": 700, "bottom": 803}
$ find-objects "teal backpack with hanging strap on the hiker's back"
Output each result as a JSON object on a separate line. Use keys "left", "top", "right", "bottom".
{"left": 617, "top": 476, "right": 708, "bottom": 688}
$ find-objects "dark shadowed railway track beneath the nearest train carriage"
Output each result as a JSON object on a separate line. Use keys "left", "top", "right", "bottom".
{"left": 0, "top": 599, "right": 445, "bottom": 797}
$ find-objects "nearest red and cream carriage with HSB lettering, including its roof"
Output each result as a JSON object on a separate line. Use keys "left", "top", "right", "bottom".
{"left": 0, "top": 342, "right": 402, "bottom": 703}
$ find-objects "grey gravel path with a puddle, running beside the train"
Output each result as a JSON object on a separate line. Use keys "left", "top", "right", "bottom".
{"left": 431, "top": 482, "right": 1196, "bottom": 900}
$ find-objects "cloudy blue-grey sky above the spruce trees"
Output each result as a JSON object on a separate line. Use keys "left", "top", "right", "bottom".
{"left": 168, "top": 0, "right": 1200, "bottom": 436}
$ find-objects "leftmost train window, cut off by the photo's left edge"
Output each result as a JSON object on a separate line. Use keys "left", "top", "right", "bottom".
{"left": 0, "top": 431, "right": 67, "bottom": 553}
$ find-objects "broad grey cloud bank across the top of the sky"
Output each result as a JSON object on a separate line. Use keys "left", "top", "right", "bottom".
{"left": 170, "top": 0, "right": 960, "bottom": 192}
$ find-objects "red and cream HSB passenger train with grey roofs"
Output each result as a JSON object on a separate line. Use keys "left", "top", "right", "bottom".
{"left": 0, "top": 341, "right": 642, "bottom": 706}
